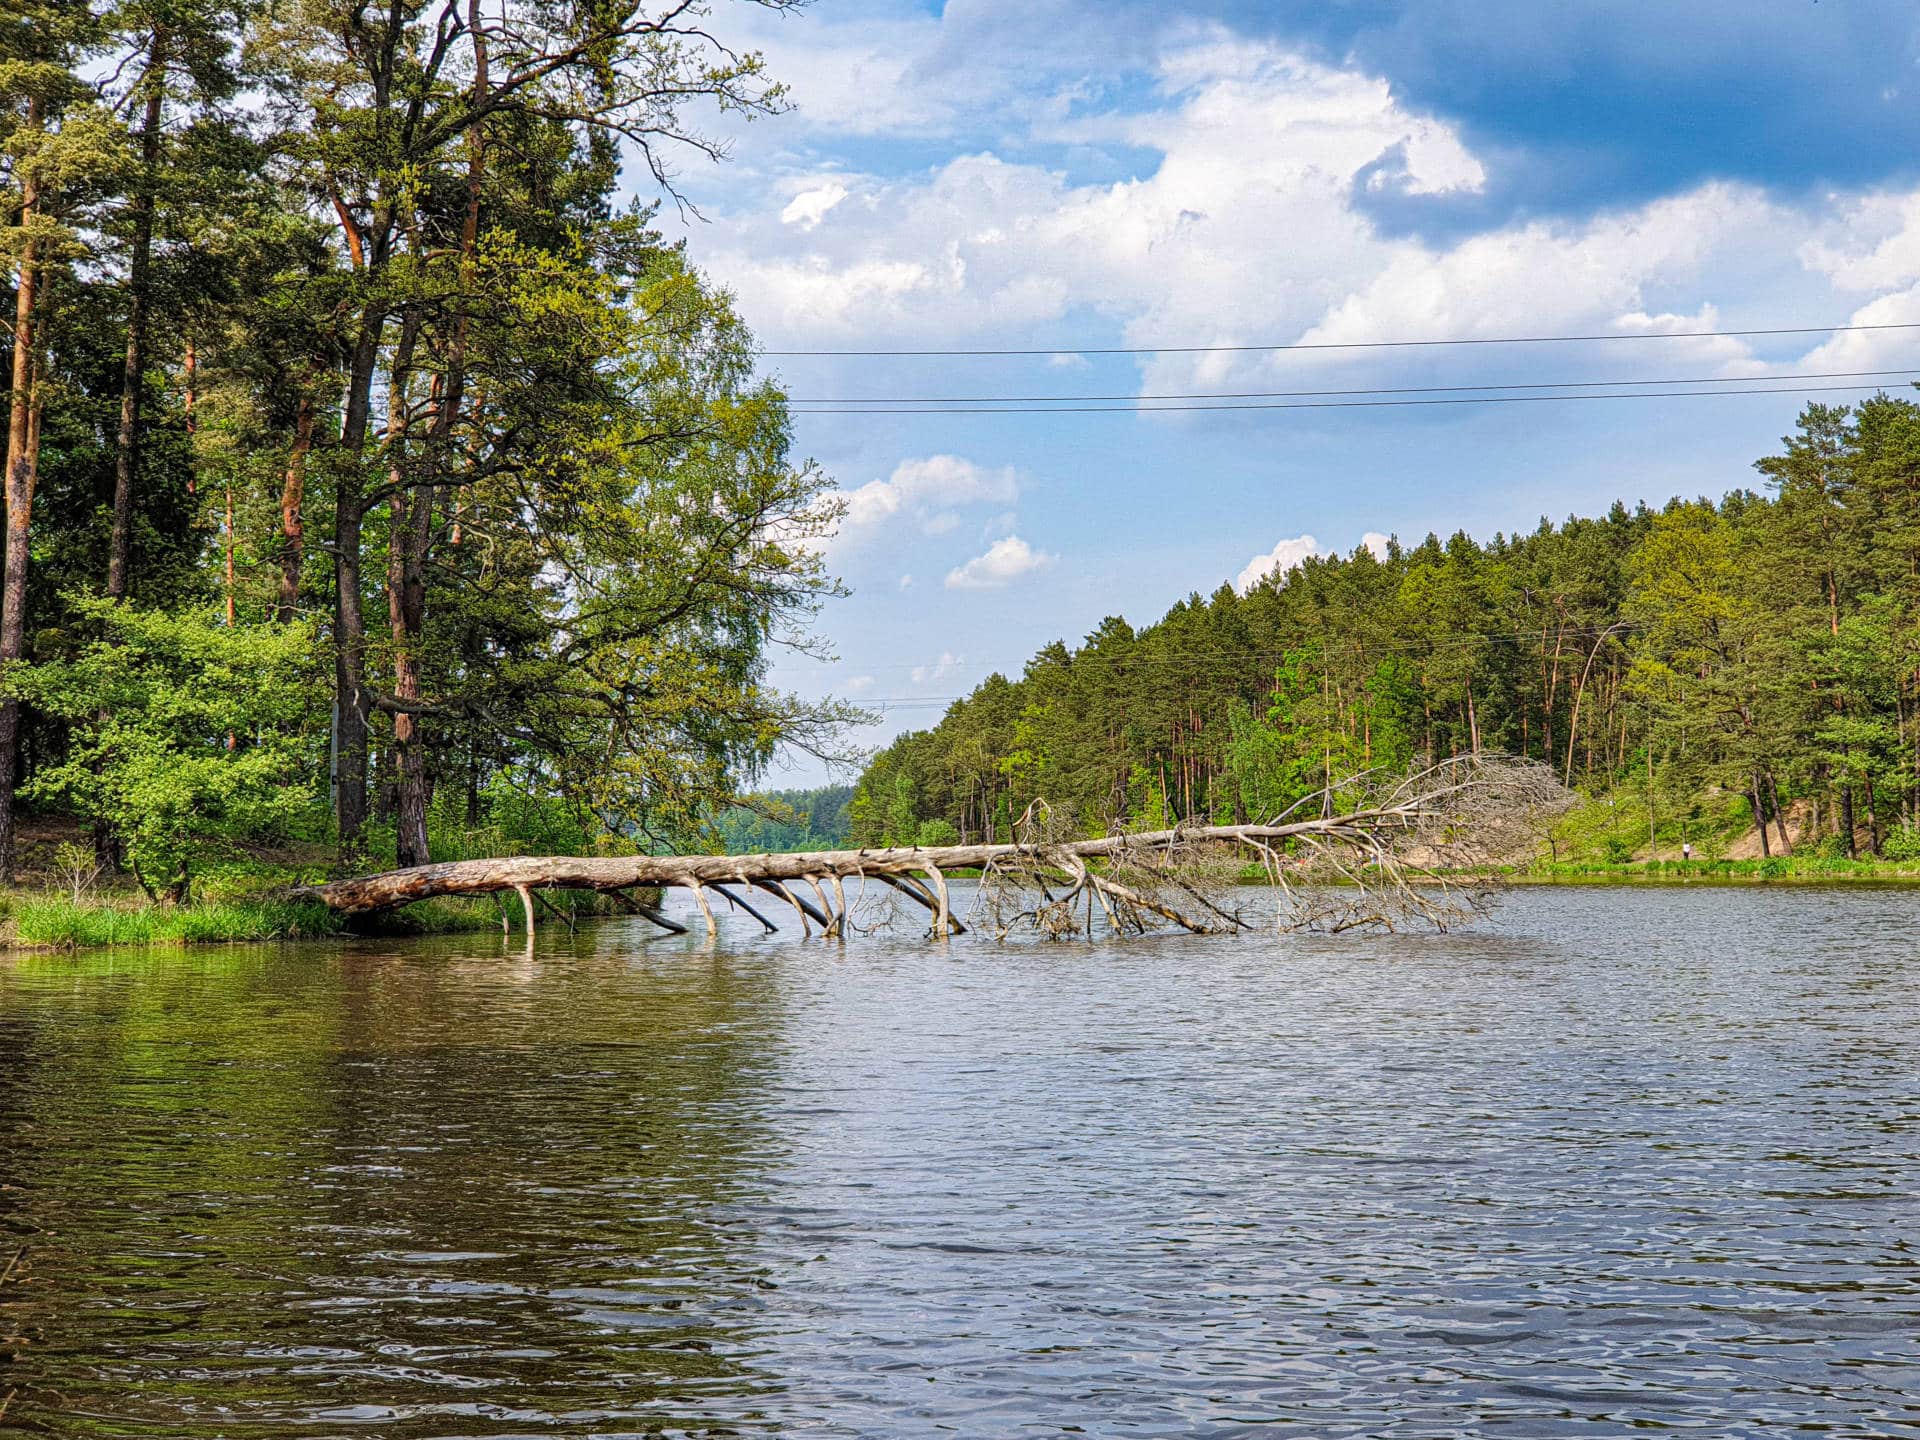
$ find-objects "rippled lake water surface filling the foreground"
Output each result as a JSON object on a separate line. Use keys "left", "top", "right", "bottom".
{"left": 0, "top": 889, "right": 1920, "bottom": 1438}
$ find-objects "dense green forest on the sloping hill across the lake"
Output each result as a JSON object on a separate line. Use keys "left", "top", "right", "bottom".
{"left": 851, "top": 396, "right": 1920, "bottom": 854}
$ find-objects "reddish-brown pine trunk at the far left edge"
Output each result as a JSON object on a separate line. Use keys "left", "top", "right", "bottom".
{"left": 0, "top": 112, "right": 40, "bottom": 885}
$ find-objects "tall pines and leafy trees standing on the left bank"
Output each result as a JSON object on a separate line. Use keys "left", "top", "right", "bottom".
{"left": 0, "top": 0, "right": 845, "bottom": 897}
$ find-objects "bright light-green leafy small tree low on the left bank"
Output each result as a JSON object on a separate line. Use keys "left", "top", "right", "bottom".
{"left": 13, "top": 601, "right": 315, "bottom": 900}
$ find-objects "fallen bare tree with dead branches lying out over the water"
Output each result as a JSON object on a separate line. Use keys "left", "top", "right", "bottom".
{"left": 294, "top": 756, "right": 1565, "bottom": 937}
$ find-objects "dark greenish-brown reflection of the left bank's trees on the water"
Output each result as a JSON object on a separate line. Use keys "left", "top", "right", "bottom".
{"left": 0, "top": 935, "right": 781, "bottom": 1436}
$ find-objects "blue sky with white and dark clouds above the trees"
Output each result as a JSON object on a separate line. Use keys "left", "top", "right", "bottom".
{"left": 648, "top": 0, "right": 1920, "bottom": 785}
